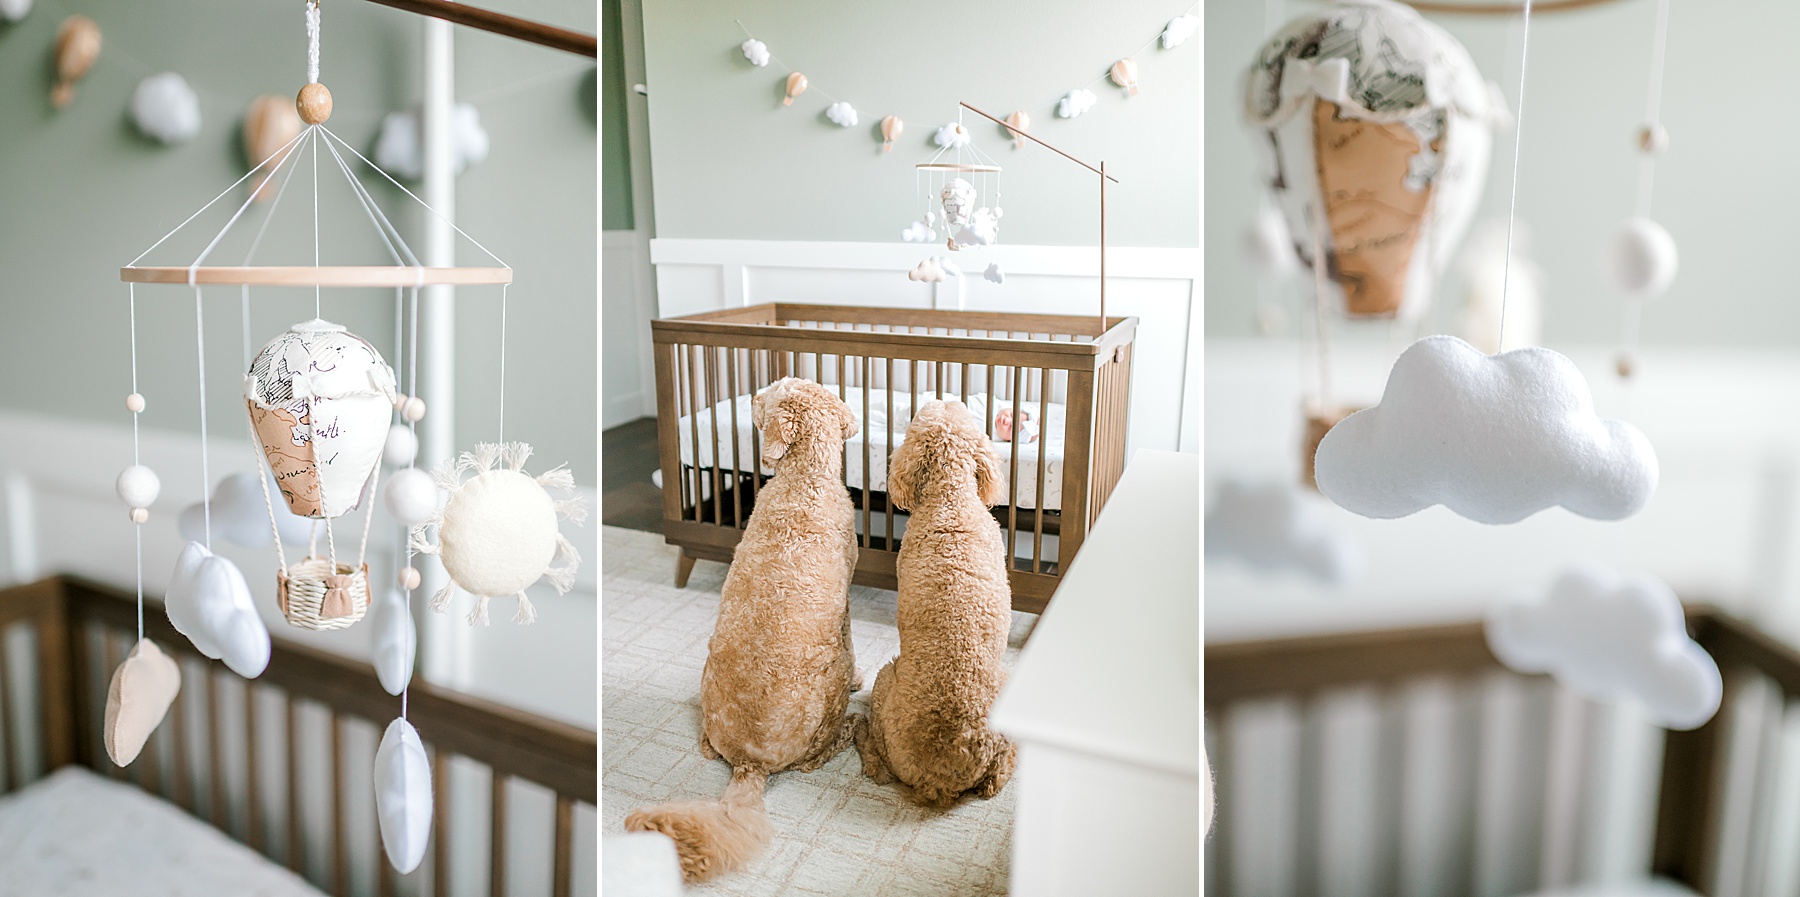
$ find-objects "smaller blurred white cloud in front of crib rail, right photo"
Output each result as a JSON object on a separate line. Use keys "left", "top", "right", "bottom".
{"left": 1487, "top": 564, "right": 1724, "bottom": 729}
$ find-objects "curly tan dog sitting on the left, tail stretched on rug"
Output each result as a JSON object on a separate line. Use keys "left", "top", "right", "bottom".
{"left": 625, "top": 376, "right": 860, "bottom": 881}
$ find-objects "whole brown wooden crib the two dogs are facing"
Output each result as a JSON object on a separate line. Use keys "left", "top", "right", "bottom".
{"left": 652, "top": 303, "right": 1138, "bottom": 612}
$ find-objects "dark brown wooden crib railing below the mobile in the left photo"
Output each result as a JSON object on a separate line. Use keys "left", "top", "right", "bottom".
{"left": 0, "top": 578, "right": 598, "bottom": 897}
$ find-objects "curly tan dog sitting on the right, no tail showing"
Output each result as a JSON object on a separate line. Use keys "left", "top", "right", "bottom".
{"left": 855, "top": 402, "right": 1013, "bottom": 807}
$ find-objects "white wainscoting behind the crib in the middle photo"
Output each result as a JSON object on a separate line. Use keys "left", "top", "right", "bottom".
{"left": 648, "top": 238, "right": 1202, "bottom": 452}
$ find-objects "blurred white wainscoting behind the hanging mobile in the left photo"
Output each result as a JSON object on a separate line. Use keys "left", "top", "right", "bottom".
{"left": 0, "top": 411, "right": 599, "bottom": 728}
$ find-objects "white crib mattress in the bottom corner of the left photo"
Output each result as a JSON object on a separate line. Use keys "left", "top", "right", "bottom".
{"left": 0, "top": 767, "right": 322, "bottom": 897}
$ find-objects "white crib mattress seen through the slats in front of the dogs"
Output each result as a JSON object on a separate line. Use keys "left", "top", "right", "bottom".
{"left": 677, "top": 387, "right": 1066, "bottom": 512}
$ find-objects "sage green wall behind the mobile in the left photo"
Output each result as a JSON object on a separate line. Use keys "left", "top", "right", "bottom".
{"left": 0, "top": 0, "right": 598, "bottom": 483}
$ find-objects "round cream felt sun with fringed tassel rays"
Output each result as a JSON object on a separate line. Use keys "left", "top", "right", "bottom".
{"left": 410, "top": 443, "right": 587, "bottom": 625}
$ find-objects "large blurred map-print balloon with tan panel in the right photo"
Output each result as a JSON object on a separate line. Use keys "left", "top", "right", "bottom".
{"left": 1244, "top": 0, "right": 1499, "bottom": 319}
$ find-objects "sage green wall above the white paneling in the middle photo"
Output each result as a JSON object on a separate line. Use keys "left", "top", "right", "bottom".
{"left": 644, "top": 0, "right": 1201, "bottom": 247}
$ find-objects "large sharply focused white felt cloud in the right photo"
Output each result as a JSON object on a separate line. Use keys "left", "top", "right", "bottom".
{"left": 1314, "top": 335, "right": 1658, "bottom": 524}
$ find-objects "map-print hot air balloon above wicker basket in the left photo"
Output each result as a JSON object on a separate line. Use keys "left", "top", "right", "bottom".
{"left": 243, "top": 319, "right": 398, "bottom": 517}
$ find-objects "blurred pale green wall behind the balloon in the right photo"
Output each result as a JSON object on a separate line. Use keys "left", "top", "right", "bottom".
{"left": 1206, "top": 0, "right": 1800, "bottom": 346}
